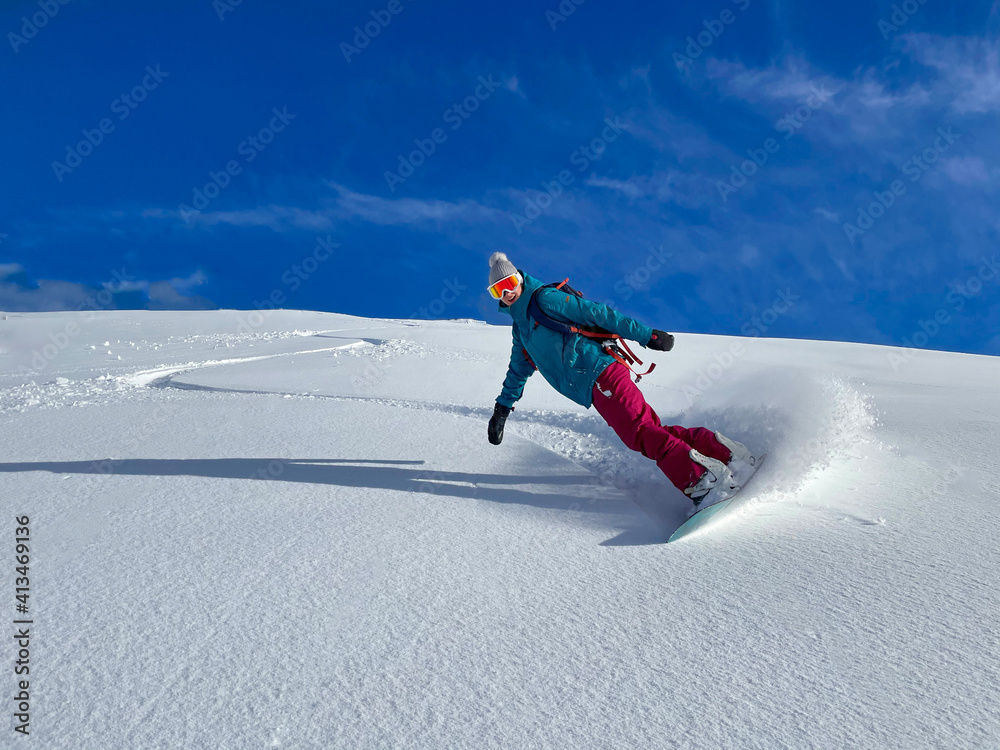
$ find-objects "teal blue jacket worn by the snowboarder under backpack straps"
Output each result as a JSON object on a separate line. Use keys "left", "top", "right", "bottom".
{"left": 497, "top": 271, "right": 653, "bottom": 409}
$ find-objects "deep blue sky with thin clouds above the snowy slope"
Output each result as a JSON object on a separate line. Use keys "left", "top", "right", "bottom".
{"left": 0, "top": 0, "right": 1000, "bottom": 354}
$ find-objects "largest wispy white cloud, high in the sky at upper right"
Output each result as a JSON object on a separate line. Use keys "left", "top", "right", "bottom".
{"left": 685, "top": 34, "right": 1000, "bottom": 212}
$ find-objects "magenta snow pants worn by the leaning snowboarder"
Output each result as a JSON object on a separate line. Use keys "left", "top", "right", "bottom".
{"left": 594, "top": 362, "right": 732, "bottom": 492}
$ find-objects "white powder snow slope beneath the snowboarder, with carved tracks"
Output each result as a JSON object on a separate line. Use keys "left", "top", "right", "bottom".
{"left": 0, "top": 311, "right": 1000, "bottom": 750}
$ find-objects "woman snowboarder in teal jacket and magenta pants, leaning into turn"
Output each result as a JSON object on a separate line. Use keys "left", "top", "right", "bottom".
{"left": 488, "top": 253, "right": 755, "bottom": 509}
